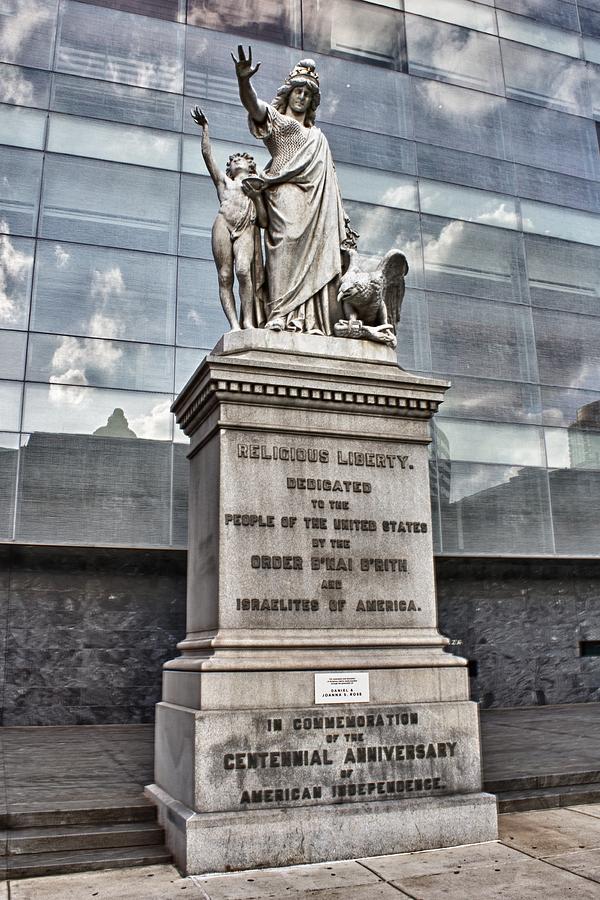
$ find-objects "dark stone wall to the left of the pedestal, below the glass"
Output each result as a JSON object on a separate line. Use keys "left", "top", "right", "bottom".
{"left": 0, "top": 544, "right": 186, "bottom": 725}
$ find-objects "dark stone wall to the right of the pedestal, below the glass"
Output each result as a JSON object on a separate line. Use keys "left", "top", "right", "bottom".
{"left": 436, "top": 557, "right": 600, "bottom": 707}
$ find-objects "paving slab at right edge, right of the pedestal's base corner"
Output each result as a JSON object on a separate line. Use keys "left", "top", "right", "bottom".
{"left": 498, "top": 809, "right": 600, "bottom": 858}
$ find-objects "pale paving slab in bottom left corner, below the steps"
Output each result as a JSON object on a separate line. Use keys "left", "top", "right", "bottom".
{"left": 7, "top": 865, "right": 206, "bottom": 900}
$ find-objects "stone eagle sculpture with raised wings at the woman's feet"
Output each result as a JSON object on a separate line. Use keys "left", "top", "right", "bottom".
{"left": 333, "top": 250, "right": 408, "bottom": 347}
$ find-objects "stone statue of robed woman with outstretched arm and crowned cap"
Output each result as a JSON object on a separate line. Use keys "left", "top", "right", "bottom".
{"left": 232, "top": 46, "right": 355, "bottom": 335}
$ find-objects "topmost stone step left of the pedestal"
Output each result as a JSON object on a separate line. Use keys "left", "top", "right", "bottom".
{"left": 2, "top": 797, "right": 156, "bottom": 828}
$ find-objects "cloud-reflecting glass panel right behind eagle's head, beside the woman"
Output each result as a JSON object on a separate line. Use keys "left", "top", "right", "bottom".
{"left": 344, "top": 200, "right": 423, "bottom": 287}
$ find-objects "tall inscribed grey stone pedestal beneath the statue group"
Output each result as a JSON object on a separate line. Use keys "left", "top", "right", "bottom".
{"left": 147, "top": 330, "right": 497, "bottom": 873}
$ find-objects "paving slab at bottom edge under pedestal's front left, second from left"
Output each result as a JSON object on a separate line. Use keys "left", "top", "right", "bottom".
{"left": 193, "top": 860, "right": 381, "bottom": 900}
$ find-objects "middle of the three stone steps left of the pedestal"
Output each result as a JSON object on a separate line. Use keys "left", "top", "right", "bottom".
{"left": 6, "top": 822, "right": 164, "bottom": 856}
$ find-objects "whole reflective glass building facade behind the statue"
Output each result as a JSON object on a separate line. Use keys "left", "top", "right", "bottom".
{"left": 0, "top": 0, "right": 600, "bottom": 558}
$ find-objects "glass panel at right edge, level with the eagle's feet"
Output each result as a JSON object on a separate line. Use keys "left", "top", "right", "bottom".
{"left": 533, "top": 309, "right": 600, "bottom": 391}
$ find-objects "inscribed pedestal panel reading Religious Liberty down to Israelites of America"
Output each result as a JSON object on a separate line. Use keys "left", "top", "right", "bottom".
{"left": 219, "top": 432, "right": 434, "bottom": 629}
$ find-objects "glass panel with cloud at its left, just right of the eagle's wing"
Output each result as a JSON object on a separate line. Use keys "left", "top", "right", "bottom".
{"left": 422, "top": 216, "right": 527, "bottom": 302}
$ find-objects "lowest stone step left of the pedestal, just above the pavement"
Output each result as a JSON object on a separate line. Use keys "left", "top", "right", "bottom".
{"left": 0, "top": 846, "right": 171, "bottom": 878}
